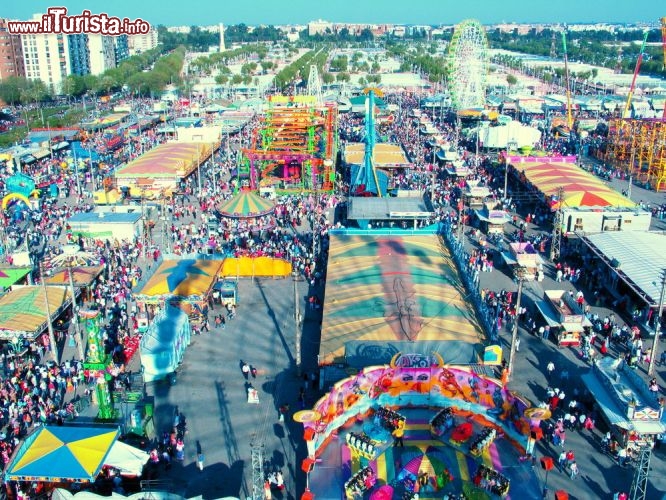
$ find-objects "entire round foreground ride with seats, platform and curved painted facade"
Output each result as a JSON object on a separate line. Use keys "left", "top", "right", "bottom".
{"left": 294, "top": 353, "right": 541, "bottom": 498}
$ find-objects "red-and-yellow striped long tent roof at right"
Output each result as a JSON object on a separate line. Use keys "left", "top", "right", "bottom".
{"left": 513, "top": 161, "right": 636, "bottom": 208}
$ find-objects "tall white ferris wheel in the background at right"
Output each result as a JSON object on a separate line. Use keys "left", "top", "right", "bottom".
{"left": 447, "top": 19, "right": 488, "bottom": 110}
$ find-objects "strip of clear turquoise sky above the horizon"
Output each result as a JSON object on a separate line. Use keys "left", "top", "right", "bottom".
{"left": 0, "top": 0, "right": 666, "bottom": 26}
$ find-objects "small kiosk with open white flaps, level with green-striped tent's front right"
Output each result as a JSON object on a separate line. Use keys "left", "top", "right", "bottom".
{"left": 536, "top": 290, "right": 592, "bottom": 347}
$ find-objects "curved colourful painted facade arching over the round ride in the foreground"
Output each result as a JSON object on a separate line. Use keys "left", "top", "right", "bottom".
{"left": 303, "top": 354, "right": 531, "bottom": 456}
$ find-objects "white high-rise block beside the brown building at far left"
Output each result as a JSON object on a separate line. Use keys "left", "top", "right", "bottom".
{"left": 21, "top": 28, "right": 72, "bottom": 93}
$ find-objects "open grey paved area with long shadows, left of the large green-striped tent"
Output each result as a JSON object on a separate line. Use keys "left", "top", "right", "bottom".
{"left": 143, "top": 278, "right": 319, "bottom": 498}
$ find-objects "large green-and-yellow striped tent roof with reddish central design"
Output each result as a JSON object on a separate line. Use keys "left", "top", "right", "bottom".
{"left": 320, "top": 233, "right": 484, "bottom": 367}
